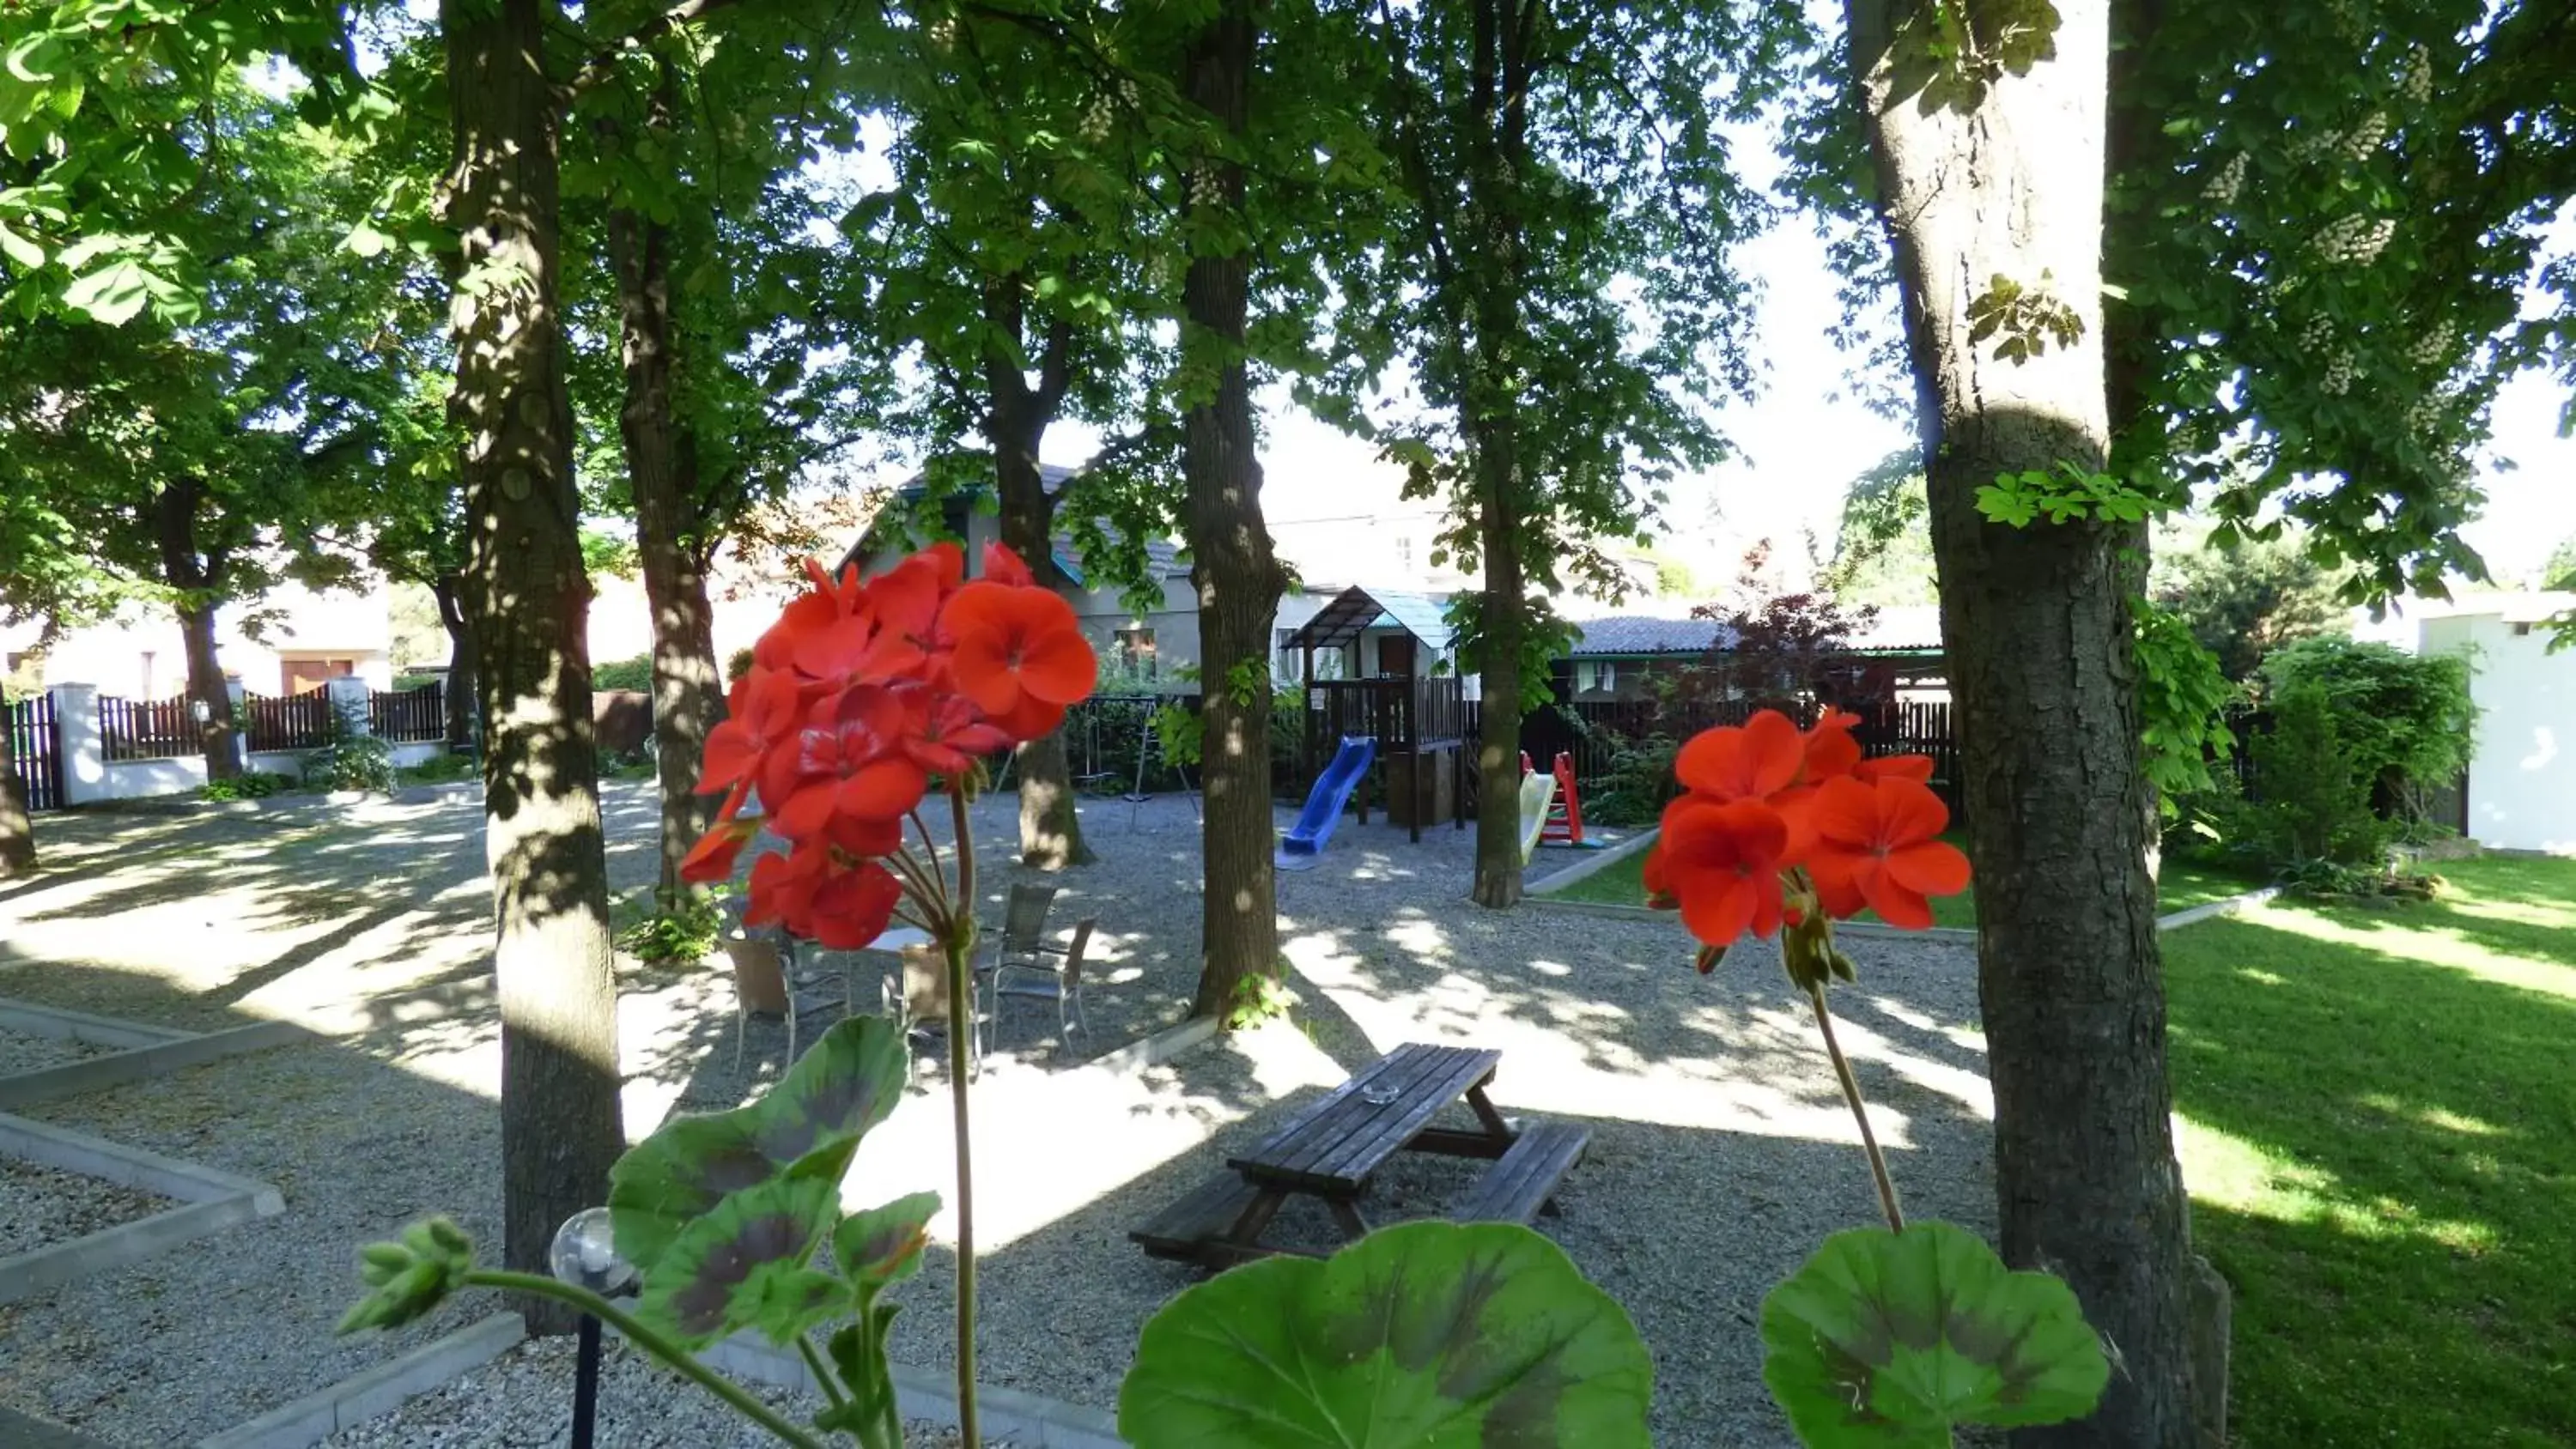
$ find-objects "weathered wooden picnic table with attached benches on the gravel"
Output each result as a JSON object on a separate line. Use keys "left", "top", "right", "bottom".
{"left": 1128, "top": 1042, "right": 1589, "bottom": 1269}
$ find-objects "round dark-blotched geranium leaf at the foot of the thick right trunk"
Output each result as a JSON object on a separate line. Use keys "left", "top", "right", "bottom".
{"left": 1762, "top": 1222, "right": 2110, "bottom": 1449}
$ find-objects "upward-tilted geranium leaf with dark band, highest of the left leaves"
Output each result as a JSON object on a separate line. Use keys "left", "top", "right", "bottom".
{"left": 608, "top": 1016, "right": 904, "bottom": 1276}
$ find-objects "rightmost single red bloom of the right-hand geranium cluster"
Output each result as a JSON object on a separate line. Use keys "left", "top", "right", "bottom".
{"left": 1806, "top": 774, "right": 1968, "bottom": 931}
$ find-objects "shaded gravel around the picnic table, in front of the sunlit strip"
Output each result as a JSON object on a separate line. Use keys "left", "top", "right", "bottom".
{"left": 891, "top": 1096, "right": 1994, "bottom": 1444}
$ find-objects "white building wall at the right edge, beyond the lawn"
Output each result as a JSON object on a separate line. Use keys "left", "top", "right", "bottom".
{"left": 2416, "top": 592, "right": 2576, "bottom": 854}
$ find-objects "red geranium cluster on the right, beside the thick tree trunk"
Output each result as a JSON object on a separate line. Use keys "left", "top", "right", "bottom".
{"left": 1646, "top": 711, "right": 1968, "bottom": 970}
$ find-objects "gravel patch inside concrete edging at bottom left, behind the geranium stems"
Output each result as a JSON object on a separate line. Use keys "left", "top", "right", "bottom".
{"left": 322, "top": 1338, "right": 984, "bottom": 1449}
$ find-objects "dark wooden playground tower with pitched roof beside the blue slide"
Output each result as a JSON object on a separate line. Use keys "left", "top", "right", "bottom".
{"left": 1285, "top": 587, "right": 1468, "bottom": 841}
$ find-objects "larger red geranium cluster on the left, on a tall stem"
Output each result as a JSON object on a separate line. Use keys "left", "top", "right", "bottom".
{"left": 680, "top": 543, "right": 1097, "bottom": 949}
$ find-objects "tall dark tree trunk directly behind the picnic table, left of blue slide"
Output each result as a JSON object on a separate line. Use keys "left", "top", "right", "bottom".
{"left": 1182, "top": 0, "right": 1288, "bottom": 1016}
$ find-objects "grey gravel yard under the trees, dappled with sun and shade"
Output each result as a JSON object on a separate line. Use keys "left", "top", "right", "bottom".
{"left": 0, "top": 785, "right": 1991, "bottom": 1446}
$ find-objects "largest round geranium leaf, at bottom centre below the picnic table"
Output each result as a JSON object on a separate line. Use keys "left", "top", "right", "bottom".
{"left": 1118, "top": 1222, "right": 1654, "bottom": 1449}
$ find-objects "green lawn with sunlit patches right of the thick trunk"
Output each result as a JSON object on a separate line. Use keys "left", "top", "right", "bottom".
{"left": 2164, "top": 859, "right": 2576, "bottom": 1449}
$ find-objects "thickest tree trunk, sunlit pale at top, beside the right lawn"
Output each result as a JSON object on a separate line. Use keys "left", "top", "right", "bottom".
{"left": 1847, "top": 0, "right": 2195, "bottom": 1446}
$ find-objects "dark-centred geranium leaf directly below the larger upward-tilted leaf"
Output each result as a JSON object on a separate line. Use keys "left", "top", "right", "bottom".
{"left": 636, "top": 1176, "right": 850, "bottom": 1346}
